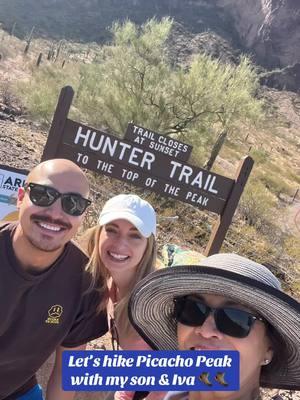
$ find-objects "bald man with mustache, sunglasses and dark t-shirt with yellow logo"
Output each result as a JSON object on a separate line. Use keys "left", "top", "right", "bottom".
{"left": 0, "top": 159, "right": 107, "bottom": 400}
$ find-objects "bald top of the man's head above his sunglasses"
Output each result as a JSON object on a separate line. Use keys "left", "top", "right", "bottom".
{"left": 26, "top": 158, "right": 89, "bottom": 197}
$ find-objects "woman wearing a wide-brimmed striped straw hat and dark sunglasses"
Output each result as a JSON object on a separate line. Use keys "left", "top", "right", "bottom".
{"left": 129, "top": 254, "right": 300, "bottom": 400}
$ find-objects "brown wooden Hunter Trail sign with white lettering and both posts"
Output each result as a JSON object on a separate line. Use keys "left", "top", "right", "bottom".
{"left": 42, "top": 86, "right": 253, "bottom": 255}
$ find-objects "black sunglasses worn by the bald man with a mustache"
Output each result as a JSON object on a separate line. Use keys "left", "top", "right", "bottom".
{"left": 24, "top": 182, "right": 91, "bottom": 217}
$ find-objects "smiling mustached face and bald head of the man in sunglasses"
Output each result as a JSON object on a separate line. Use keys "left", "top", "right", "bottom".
{"left": 18, "top": 160, "right": 89, "bottom": 252}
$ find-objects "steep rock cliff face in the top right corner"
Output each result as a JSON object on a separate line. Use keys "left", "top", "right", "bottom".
{"left": 217, "top": 0, "right": 300, "bottom": 68}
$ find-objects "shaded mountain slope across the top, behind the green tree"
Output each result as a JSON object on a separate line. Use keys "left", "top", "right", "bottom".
{"left": 0, "top": 0, "right": 300, "bottom": 71}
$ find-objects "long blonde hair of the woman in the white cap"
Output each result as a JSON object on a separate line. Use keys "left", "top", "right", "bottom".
{"left": 85, "top": 225, "right": 156, "bottom": 335}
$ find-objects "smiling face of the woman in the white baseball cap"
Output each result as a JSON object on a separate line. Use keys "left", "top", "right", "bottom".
{"left": 99, "top": 219, "right": 147, "bottom": 274}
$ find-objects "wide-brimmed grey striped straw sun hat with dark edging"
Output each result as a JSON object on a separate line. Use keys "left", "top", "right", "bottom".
{"left": 129, "top": 254, "right": 300, "bottom": 390}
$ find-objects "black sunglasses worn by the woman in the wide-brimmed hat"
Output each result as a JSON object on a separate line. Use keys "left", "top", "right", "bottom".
{"left": 174, "top": 296, "right": 264, "bottom": 338}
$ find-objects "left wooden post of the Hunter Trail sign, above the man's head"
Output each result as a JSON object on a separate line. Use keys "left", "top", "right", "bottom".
{"left": 41, "top": 86, "right": 74, "bottom": 161}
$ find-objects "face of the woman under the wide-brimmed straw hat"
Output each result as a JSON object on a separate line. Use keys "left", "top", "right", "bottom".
{"left": 177, "top": 295, "right": 273, "bottom": 398}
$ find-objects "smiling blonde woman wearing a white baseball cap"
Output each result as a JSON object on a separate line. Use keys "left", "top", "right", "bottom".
{"left": 87, "top": 194, "right": 162, "bottom": 399}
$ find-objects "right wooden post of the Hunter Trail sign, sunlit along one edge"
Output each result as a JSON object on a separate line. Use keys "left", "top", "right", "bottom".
{"left": 204, "top": 156, "right": 254, "bottom": 256}
